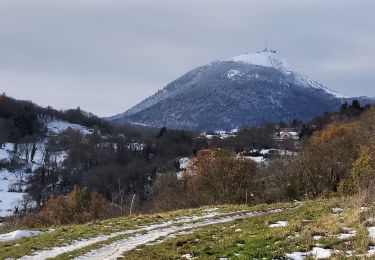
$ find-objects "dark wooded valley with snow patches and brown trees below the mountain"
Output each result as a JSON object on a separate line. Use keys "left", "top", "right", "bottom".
{"left": 0, "top": 92, "right": 375, "bottom": 230}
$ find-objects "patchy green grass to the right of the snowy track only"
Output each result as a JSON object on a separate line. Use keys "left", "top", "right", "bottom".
{"left": 124, "top": 200, "right": 374, "bottom": 260}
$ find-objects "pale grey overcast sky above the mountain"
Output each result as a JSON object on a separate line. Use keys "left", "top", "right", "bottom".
{"left": 0, "top": 0, "right": 375, "bottom": 116}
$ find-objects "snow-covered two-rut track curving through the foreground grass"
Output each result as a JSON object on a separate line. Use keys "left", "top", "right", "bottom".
{"left": 21, "top": 208, "right": 288, "bottom": 259}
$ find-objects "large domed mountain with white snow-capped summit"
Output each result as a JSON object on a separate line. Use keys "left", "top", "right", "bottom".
{"left": 110, "top": 49, "right": 343, "bottom": 130}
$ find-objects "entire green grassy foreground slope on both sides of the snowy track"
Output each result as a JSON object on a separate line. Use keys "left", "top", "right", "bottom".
{"left": 0, "top": 198, "right": 375, "bottom": 259}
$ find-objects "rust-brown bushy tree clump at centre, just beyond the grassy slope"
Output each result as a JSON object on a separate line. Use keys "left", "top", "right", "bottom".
{"left": 147, "top": 150, "right": 259, "bottom": 211}
